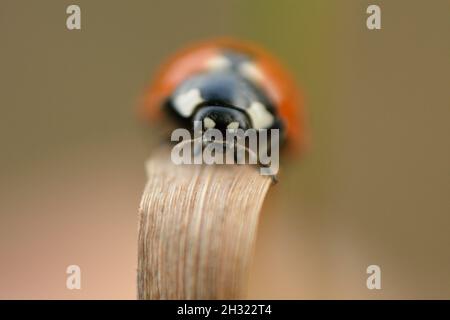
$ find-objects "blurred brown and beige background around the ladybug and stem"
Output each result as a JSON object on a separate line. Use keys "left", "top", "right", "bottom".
{"left": 0, "top": 0, "right": 450, "bottom": 299}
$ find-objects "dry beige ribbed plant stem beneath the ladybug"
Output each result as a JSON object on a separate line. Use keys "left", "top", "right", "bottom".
{"left": 137, "top": 150, "right": 272, "bottom": 299}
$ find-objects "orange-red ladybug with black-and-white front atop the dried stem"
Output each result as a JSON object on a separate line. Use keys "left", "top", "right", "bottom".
{"left": 144, "top": 39, "right": 304, "bottom": 149}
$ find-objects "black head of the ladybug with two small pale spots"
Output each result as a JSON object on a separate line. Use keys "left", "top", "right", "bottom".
{"left": 193, "top": 105, "right": 251, "bottom": 134}
